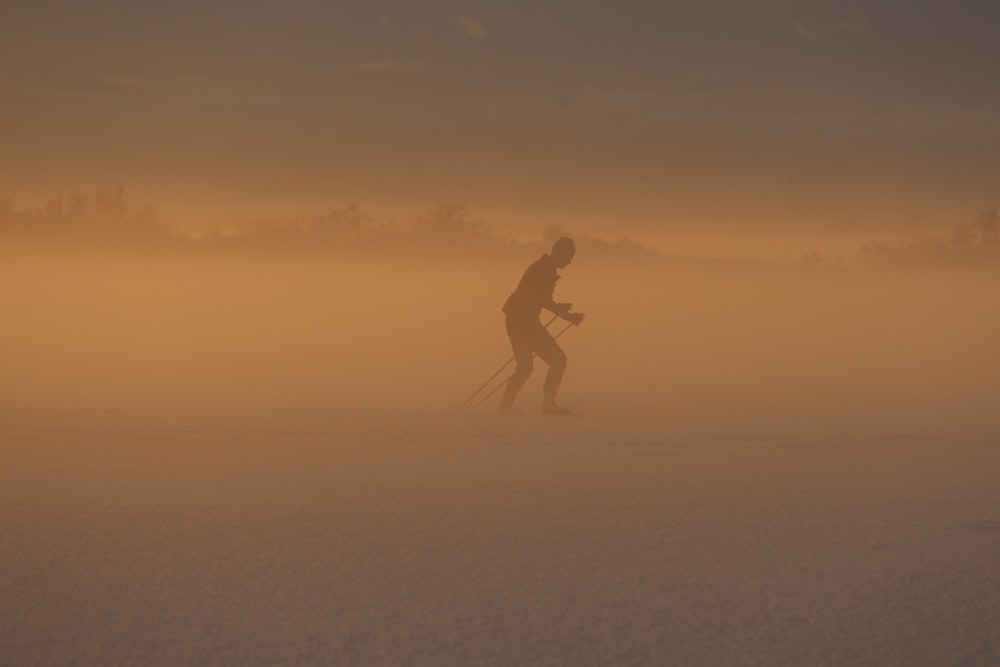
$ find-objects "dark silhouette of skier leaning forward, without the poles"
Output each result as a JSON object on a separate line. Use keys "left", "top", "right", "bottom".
{"left": 500, "top": 236, "right": 583, "bottom": 415}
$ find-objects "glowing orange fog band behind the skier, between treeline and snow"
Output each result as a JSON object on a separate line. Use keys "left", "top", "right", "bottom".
{"left": 0, "top": 252, "right": 1000, "bottom": 433}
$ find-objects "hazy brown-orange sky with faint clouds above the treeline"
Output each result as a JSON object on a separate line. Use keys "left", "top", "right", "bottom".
{"left": 0, "top": 0, "right": 1000, "bottom": 224}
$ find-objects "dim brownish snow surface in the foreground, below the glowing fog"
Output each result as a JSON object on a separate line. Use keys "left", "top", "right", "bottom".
{"left": 0, "top": 413, "right": 1000, "bottom": 665}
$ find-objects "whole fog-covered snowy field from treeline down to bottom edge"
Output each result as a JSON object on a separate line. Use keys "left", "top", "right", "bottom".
{"left": 0, "top": 253, "right": 1000, "bottom": 667}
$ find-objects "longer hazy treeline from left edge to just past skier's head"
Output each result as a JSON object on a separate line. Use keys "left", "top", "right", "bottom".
{"left": 0, "top": 188, "right": 664, "bottom": 261}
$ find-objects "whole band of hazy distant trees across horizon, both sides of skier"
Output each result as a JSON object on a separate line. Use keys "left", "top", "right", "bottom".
{"left": 0, "top": 188, "right": 1000, "bottom": 268}
